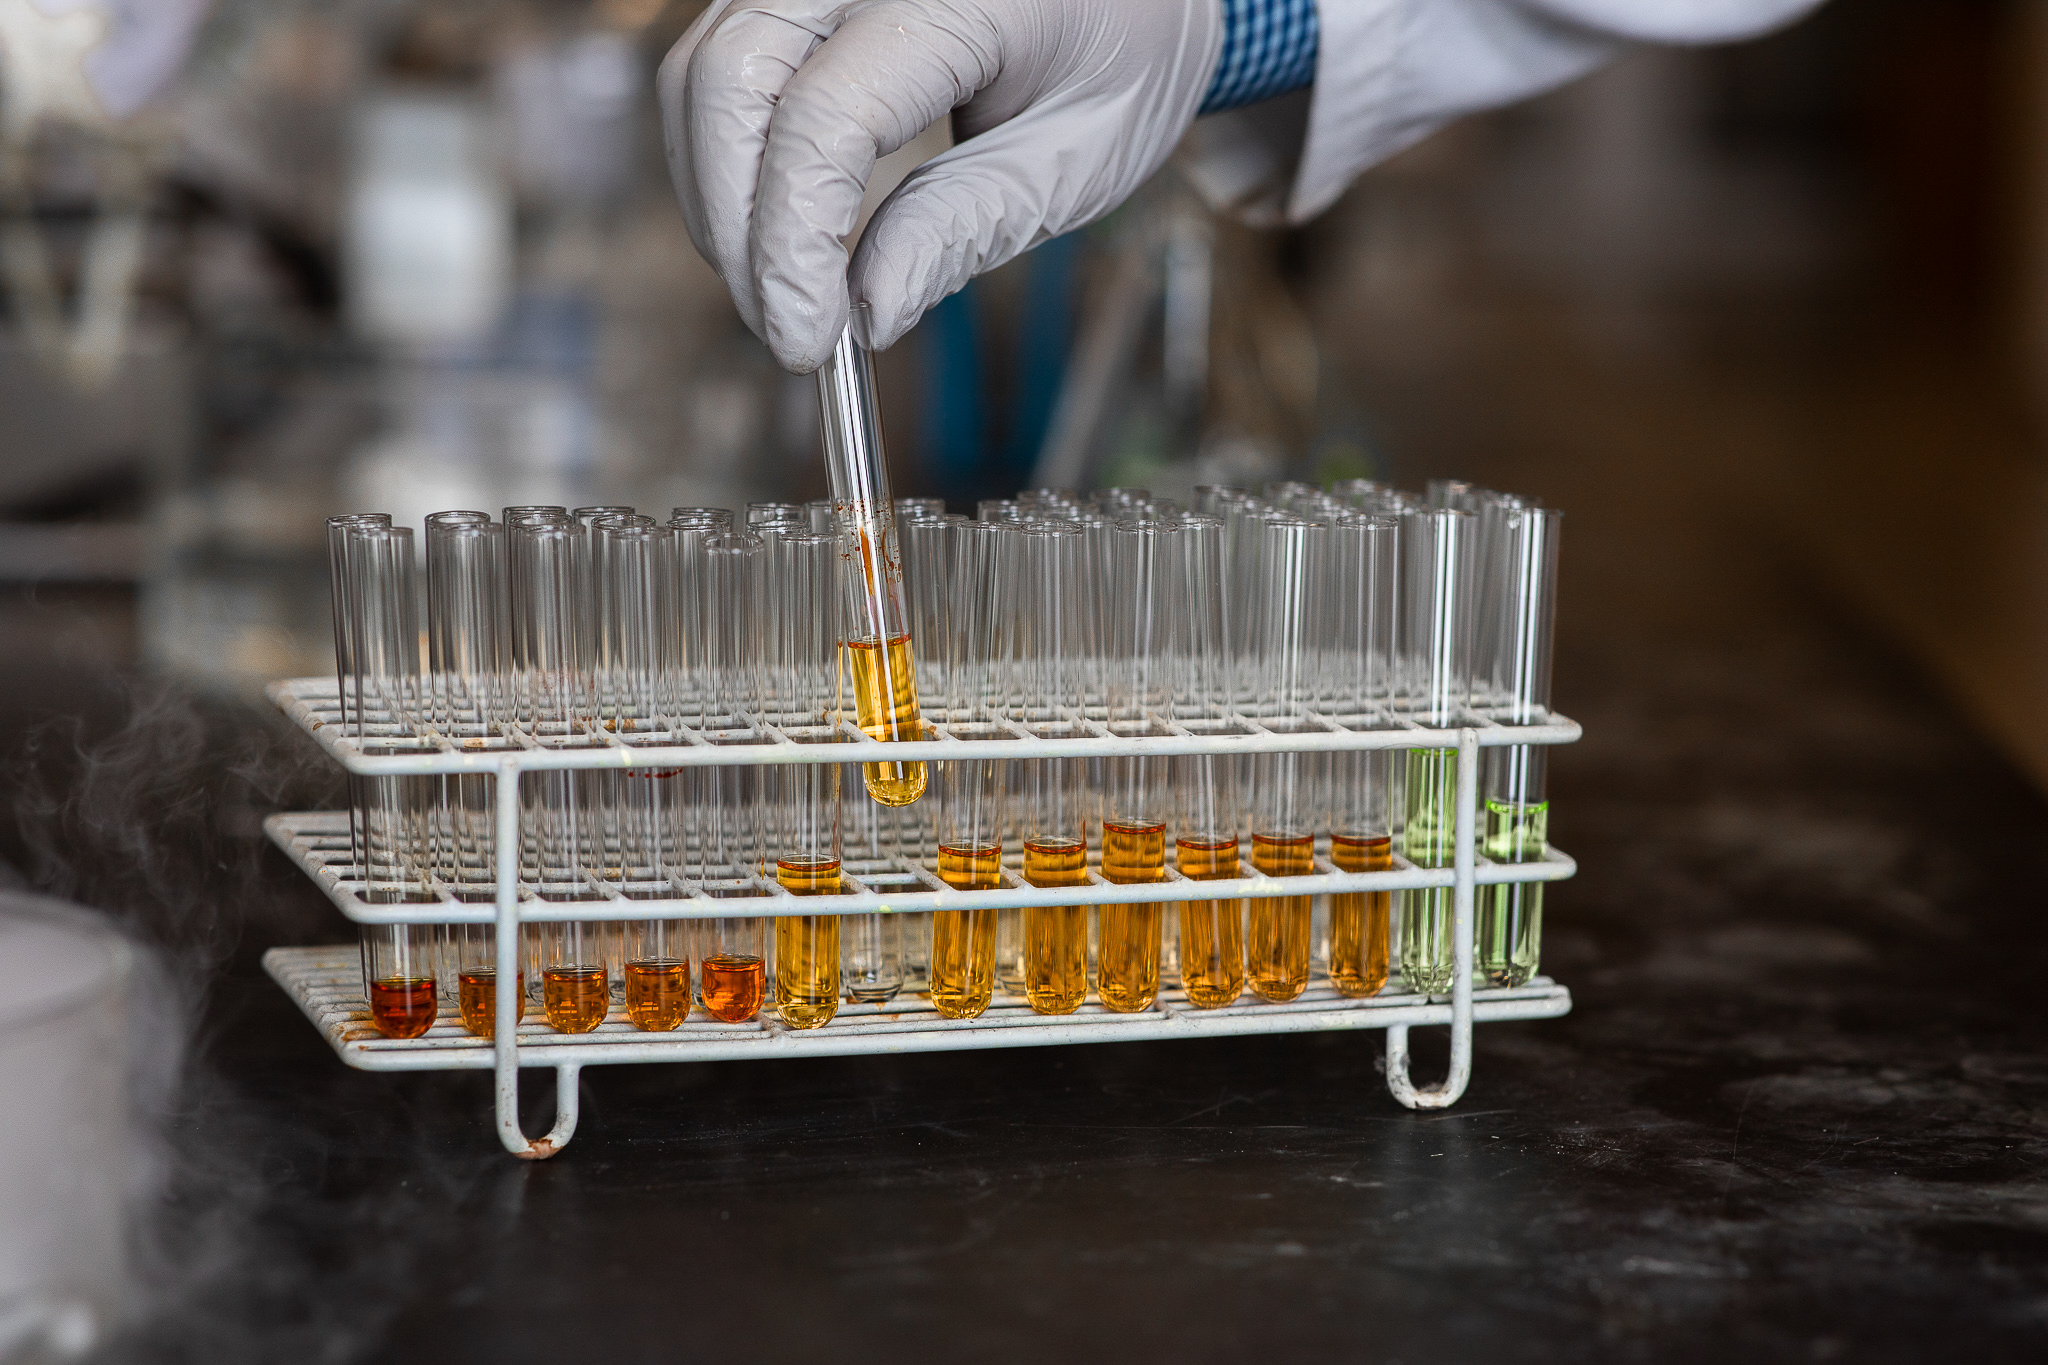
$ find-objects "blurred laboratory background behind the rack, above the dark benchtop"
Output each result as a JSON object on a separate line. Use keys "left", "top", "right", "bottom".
{"left": 0, "top": 0, "right": 2048, "bottom": 757}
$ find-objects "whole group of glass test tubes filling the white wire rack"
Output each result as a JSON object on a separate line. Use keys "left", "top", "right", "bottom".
{"left": 330, "top": 481, "right": 1559, "bottom": 1036}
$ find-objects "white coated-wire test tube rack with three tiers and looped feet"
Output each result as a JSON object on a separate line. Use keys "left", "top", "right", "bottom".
{"left": 264, "top": 677, "right": 1581, "bottom": 1160}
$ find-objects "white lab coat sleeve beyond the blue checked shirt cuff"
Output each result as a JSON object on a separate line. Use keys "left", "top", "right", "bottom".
{"left": 1180, "top": 0, "right": 1819, "bottom": 223}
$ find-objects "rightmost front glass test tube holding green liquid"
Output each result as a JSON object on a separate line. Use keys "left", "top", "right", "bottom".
{"left": 1475, "top": 508, "right": 1563, "bottom": 986}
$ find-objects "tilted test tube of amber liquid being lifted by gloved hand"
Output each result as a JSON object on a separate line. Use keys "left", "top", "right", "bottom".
{"left": 817, "top": 305, "right": 926, "bottom": 806}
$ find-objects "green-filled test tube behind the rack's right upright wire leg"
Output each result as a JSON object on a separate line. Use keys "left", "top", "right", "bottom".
{"left": 1399, "top": 507, "right": 1475, "bottom": 995}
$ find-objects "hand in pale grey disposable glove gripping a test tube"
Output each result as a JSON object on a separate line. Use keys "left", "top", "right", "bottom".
{"left": 662, "top": 0, "right": 1223, "bottom": 375}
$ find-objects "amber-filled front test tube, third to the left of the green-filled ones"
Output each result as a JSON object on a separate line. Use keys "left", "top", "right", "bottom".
{"left": 1174, "top": 516, "right": 1245, "bottom": 1009}
